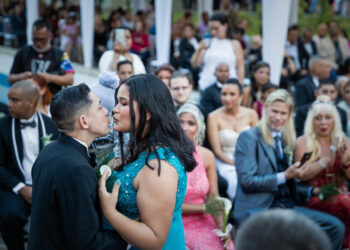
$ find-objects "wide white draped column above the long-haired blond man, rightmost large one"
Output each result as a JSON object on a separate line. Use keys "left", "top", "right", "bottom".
{"left": 262, "top": 0, "right": 291, "bottom": 85}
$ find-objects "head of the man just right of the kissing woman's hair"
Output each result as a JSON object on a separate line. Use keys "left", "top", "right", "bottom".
{"left": 169, "top": 72, "right": 193, "bottom": 109}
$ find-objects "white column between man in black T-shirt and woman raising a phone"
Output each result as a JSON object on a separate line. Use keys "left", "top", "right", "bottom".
{"left": 80, "top": 0, "right": 95, "bottom": 68}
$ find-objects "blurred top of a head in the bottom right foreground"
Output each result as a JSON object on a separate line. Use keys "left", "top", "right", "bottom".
{"left": 235, "top": 209, "right": 332, "bottom": 250}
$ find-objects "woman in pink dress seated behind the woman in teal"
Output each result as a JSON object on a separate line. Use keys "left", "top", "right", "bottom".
{"left": 177, "top": 104, "right": 234, "bottom": 250}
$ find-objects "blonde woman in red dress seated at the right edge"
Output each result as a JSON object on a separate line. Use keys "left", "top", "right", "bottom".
{"left": 294, "top": 100, "right": 350, "bottom": 248}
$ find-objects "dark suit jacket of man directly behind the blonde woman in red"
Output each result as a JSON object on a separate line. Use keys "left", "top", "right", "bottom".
{"left": 294, "top": 104, "right": 348, "bottom": 137}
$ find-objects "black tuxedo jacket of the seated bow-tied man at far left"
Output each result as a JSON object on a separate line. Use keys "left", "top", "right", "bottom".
{"left": 0, "top": 113, "right": 58, "bottom": 192}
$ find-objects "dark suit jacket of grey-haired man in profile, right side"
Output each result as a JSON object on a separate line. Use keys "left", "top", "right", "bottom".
{"left": 294, "top": 75, "right": 316, "bottom": 108}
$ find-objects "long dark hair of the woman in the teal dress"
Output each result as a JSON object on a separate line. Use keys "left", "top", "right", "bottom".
{"left": 116, "top": 74, "right": 197, "bottom": 175}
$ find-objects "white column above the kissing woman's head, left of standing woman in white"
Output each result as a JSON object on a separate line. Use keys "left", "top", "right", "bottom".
{"left": 152, "top": 0, "right": 172, "bottom": 66}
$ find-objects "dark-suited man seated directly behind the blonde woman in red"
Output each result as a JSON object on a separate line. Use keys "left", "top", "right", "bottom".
{"left": 295, "top": 79, "right": 347, "bottom": 136}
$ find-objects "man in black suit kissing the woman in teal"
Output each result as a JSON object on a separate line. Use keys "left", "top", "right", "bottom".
{"left": 28, "top": 84, "right": 126, "bottom": 250}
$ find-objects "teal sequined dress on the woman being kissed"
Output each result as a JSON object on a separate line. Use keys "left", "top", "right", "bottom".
{"left": 104, "top": 148, "right": 187, "bottom": 250}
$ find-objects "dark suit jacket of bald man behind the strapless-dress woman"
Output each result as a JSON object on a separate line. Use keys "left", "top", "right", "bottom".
{"left": 200, "top": 83, "right": 222, "bottom": 117}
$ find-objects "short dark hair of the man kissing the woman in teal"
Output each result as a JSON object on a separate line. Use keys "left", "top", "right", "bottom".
{"left": 50, "top": 83, "right": 92, "bottom": 132}
